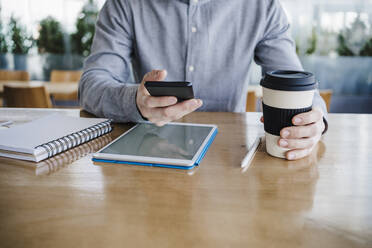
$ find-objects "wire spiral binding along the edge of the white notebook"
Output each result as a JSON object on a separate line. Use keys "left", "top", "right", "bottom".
{"left": 35, "top": 120, "right": 112, "bottom": 158}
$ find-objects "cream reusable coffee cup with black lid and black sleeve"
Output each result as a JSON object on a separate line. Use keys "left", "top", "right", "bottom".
{"left": 261, "top": 70, "right": 318, "bottom": 158}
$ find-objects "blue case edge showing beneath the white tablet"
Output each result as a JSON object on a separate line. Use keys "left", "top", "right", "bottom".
{"left": 92, "top": 128, "right": 218, "bottom": 170}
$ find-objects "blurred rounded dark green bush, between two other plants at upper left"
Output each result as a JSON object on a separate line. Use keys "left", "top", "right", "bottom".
{"left": 36, "top": 16, "right": 66, "bottom": 54}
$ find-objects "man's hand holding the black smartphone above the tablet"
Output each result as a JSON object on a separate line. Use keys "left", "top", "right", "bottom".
{"left": 136, "top": 70, "right": 203, "bottom": 126}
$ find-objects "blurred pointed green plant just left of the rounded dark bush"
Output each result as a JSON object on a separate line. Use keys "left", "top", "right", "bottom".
{"left": 9, "top": 16, "right": 34, "bottom": 54}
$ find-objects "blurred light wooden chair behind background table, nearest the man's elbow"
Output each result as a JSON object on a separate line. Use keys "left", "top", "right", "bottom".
{"left": 50, "top": 70, "right": 83, "bottom": 101}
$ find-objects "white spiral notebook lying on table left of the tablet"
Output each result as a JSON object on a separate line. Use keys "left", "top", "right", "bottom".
{"left": 0, "top": 114, "right": 112, "bottom": 162}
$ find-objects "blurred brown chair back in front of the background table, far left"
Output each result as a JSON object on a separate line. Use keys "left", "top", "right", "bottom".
{"left": 4, "top": 84, "right": 52, "bottom": 108}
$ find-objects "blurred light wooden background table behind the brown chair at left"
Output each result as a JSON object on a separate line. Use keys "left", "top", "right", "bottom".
{"left": 0, "top": 81, "right": 79, "bottom": 96}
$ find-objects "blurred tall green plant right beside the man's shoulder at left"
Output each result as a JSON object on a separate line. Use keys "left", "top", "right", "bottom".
{"left": 71, "top": 0, "right": 98, "bottom": 56}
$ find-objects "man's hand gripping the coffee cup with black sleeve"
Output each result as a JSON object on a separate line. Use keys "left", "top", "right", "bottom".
{"left": 261, "top": 108, "right": 325, "bottom": 160}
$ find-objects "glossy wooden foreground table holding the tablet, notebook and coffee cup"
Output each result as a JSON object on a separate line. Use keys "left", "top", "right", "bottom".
{"left": 0, "top": 109, "right": 372, "bottom": 248}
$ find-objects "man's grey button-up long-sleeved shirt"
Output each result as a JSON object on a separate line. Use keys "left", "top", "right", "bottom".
{"left": 79, "top": 0, "right": 326, "bottom": 122}
